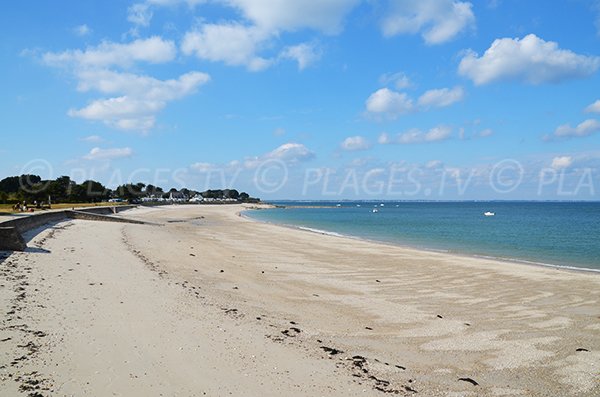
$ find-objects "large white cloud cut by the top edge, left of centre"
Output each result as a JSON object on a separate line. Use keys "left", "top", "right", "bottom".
{"left": 178, "top": 0, "right": 360, "bottom": 71}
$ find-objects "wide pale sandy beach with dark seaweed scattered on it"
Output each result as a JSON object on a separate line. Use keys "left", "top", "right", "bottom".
{"left": 0, "top": 205, "right": 600, "bottom": 396}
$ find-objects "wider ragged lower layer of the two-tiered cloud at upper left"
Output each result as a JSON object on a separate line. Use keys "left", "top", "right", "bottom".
{"left": 68, "top": 70, "right": 209, "bottom": 132}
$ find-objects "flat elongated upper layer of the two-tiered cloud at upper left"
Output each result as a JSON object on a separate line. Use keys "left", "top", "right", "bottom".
{"left": 42, "top": 36, "right": 177, "bottom": 68}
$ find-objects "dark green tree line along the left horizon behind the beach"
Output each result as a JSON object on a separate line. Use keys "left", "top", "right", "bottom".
{"left": 0, "top": 174, "right": 259, "bottom": 204}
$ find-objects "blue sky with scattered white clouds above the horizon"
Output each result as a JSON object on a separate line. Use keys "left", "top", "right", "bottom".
{"left": 0, "top": 0, "right": 600, "bottom": 200}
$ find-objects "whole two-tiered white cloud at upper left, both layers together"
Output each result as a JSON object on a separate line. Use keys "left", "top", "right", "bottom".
{"left": 43, "top": 36, "right": 210, "bottom": 132}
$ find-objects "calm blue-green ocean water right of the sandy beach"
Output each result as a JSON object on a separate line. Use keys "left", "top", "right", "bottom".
{"left": 246, "top": 201, "right": 600, "bottom": 271}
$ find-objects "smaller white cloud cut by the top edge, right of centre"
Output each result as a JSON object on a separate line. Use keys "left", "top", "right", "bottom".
{"left": 381, "top": 0, "right": 475, "bottom": 44}
